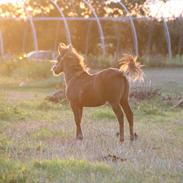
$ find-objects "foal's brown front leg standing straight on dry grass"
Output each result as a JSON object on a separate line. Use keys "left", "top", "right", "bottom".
{"left": 71, "top": 103, "right": 83, "bottom": 140}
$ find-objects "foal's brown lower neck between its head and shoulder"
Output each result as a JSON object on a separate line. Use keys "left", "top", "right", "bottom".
{"left": 64, "top": 66, "right": 88, "bottom": 84}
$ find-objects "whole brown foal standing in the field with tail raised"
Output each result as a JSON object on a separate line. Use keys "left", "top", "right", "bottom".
{"left": 52, "top": 44, "right": 143, "bottom": 142}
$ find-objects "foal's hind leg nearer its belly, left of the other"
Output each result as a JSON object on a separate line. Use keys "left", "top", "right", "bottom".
{"left": 111, "top": 103, "right": 124, "bottom": 142}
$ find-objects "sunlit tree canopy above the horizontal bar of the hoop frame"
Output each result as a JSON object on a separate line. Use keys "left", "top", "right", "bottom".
{"left": 0, "top": 0, "right": 157, "bottom": 17}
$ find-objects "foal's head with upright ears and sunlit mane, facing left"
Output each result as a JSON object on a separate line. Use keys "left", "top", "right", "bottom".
{"left": 52, "top": 43, "right": 86, "bottom": 75}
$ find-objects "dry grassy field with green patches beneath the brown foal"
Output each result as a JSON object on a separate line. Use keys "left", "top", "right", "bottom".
{"left": 0, "top": 68, "right": 183, "bottom": 183}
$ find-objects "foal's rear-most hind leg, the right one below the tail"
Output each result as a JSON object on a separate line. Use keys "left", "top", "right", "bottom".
{"left": 121, "top": 99, "right": 137, "bottom": 140}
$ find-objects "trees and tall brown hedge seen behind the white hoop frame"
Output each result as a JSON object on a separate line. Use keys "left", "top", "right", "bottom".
{"left": 0, "top": 0, "right": 180, "bottom": 55}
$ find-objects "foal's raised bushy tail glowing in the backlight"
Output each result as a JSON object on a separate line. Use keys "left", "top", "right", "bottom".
{"left": 119, "top": 54, "right": 144, "bottom": 81}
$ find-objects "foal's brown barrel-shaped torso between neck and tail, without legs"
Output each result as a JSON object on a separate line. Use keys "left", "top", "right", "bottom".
{"left": 67, "top": 68, "right": 128, "bottom": 107}
